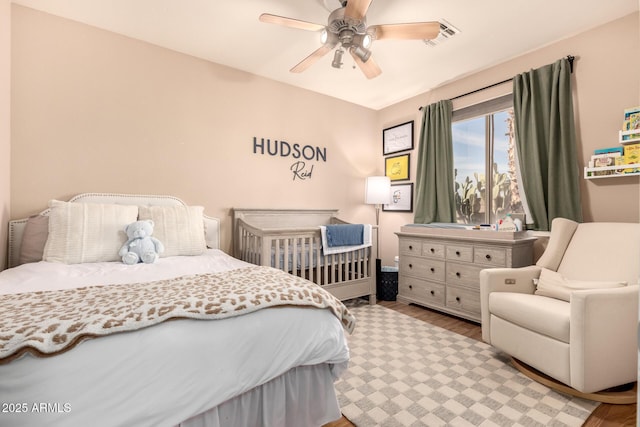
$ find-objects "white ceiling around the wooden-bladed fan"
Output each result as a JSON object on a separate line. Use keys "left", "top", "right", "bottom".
{"left": 14, "top": 0, "right": 639, "bottom": 110}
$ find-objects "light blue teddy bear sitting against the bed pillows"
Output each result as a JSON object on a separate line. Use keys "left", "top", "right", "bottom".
{"left": 118, "top": 219, "right": 164, "bottom": 265}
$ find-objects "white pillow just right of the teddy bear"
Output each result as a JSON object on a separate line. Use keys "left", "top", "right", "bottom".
{"left": 139, "top": 206, "right": 207, "bottom": 257}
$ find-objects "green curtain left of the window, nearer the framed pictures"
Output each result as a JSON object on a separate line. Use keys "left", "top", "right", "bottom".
{"left": 414, "top": 100, "right": 456, "bottom": 224}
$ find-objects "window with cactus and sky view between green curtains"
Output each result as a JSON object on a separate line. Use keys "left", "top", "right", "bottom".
{"left": 451, "top": 95, "right": 524, "bottom": 224}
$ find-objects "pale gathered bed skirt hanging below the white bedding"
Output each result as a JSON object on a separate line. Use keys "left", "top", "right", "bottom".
{"left": 179, "top": 364, "right": 342, "bottom": 427}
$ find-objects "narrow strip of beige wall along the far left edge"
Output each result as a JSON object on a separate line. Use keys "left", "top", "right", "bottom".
{"left": 0, "top": 0, "right": 11, "bottom": 270}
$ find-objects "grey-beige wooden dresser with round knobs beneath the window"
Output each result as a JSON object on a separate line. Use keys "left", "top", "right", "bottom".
{"left": 396, "top": 225, "right": 536, "bottom": 322}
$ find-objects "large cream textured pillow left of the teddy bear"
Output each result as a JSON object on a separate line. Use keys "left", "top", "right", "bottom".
{"left": 43, "top": 200, "right": 138, "bottom": 264}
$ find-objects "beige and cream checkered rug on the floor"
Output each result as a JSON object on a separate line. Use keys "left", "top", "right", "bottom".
{"left": 336, "top": 304, "right": 598, "bottom": 427}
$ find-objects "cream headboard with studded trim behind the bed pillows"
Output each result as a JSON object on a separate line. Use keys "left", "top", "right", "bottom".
{"left": 8, "top": 193, "right": 220, "bottom": 267}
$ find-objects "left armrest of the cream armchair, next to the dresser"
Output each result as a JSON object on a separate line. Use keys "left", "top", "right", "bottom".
{"left": 480, "top": 265, "right": 541, "bottom": 344}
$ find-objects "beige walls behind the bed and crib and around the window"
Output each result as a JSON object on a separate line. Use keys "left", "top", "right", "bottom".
{"left": 8, "top": 5, "right": 640, "bottom": 264}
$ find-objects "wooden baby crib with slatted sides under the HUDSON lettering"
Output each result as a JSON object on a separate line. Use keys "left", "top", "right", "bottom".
{"left": 233, "top": 208, "right": 378, "bottom": 304}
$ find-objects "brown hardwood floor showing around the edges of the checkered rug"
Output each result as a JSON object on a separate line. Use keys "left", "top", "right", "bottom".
{"left": 323, "top": 301, "right": 637, "bottom": 427}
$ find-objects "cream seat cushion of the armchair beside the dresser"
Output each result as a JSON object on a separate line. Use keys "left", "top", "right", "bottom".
{"left": 489, "top": 292, "right": 571, "bottom": 343}
